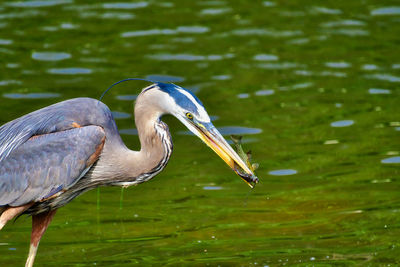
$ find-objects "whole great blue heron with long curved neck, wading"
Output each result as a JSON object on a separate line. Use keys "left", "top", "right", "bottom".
{"left": 0, "top": 82, "right": 258, "bottom": 266}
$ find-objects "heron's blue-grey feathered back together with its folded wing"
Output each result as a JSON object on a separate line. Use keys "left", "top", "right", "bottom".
{"left": 0, "top": 98, "right": 123, "bottom": 214}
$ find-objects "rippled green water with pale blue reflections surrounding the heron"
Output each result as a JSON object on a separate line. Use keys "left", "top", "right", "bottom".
{"left": 0, "top": 0, "right": 400, "bottom": 266}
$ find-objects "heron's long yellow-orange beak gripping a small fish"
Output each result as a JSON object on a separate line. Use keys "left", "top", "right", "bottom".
{"left": 194, "top": 123, "right": 258, "bottom": 188}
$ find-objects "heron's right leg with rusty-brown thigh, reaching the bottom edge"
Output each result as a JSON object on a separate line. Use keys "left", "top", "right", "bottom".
{"left": 25, "top": 210, "right": 57, "bottom": 267}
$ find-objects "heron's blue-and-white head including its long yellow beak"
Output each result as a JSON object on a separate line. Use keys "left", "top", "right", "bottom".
{"left": 143, "top": 83, "right": 258, "bottom": 187}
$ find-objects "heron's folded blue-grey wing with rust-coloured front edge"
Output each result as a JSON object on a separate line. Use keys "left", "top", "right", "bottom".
{"left": 0, "top": 126, "right": 105, "bottom": 206}
